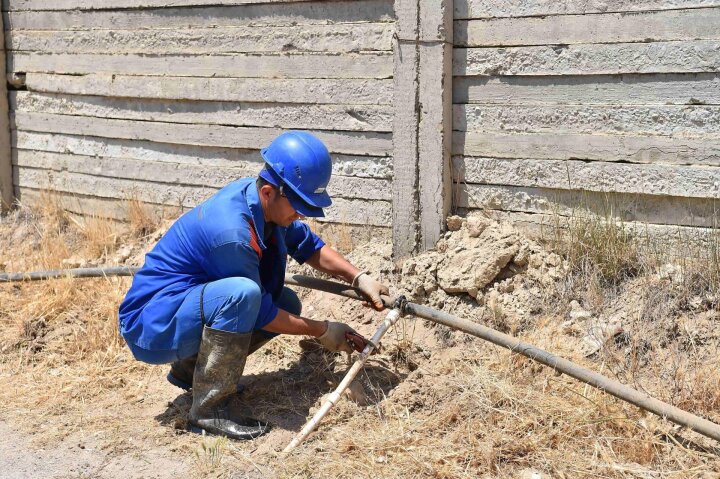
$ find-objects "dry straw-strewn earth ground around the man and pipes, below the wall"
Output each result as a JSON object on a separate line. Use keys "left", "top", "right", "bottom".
{"left": 0, "top": 206, "right": 720, "bottom": 478}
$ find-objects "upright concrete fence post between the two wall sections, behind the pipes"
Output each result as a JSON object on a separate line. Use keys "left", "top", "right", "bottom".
{"left": 393, "top": 0, "right": 453, "bottom": 260}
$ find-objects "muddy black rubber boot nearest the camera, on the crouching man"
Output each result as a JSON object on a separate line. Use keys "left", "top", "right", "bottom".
{"left": 188, "top": 326, "right": 270, "bottom": 440}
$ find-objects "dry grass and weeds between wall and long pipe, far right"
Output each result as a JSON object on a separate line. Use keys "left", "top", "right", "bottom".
{"left": 551, "top": 206, "right": 720, "bottom": 442}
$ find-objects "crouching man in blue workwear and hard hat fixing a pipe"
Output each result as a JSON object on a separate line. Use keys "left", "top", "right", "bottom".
{"left": 119, "top": 131, "right": 388, "bottom": 439}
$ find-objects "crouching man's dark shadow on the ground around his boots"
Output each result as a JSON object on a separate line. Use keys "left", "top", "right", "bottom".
{"left": 155, "top": 349, "right": 407, "bottom": 431}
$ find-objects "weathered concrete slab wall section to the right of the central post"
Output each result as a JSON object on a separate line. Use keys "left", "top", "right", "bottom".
{"left": 452, "top": 0, "right": 720, "bottom": 234}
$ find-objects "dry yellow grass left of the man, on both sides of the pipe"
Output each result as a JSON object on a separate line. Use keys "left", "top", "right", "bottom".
{"left": 0, "top": 194, "right": 158, "bottom": 446}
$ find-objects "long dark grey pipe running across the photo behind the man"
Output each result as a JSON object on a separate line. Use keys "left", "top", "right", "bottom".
{"left": 0, "top": 267, "right": 720, "bottom": 442}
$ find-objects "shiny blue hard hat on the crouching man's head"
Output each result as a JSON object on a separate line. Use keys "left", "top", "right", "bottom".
{"left": 260, "top": 131, "right": 332, "bottom": 216}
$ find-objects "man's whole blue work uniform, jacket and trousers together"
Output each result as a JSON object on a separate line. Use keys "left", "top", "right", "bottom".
{"left": 120, "top": 178, "right": 325, "bottom": 364}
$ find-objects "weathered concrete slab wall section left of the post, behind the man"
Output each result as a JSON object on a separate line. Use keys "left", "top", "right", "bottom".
{"left": 2, "top": 0, "right": 395, "bottom": 232}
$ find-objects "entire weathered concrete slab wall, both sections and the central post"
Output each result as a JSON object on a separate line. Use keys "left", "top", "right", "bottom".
{"left": 7, "top": 0, "right": 720, "bottom": 251}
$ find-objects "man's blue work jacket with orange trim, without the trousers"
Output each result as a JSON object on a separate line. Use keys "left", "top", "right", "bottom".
{"left": 119, "top": 178, "right": 325, "bottom": 351}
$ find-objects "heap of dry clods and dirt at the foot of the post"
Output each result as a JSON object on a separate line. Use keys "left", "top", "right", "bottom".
{"left": 397, "top": 215, "right": 567, "bottom": 331}
